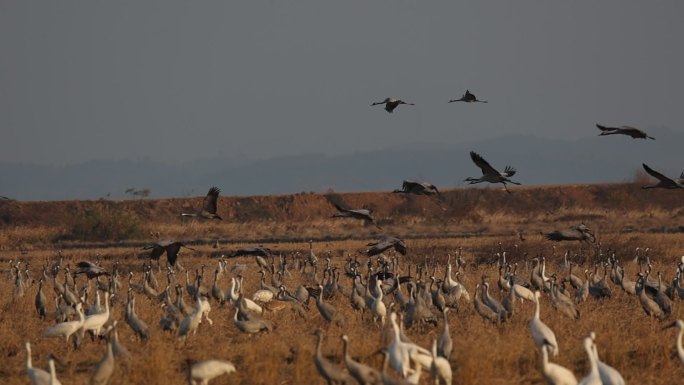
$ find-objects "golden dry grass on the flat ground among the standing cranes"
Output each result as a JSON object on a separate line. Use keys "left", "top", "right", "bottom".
{"left": 0, "top": 234, "right": 684, "bottom": 384}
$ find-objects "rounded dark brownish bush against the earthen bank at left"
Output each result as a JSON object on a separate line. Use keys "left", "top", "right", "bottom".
{"left": 63, "top": 202, "right": 145, "bottom": 241}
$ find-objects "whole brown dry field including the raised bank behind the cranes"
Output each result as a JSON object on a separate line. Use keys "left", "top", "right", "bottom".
{"left": 0, "top": 185, "right": 684, "bottom": 385}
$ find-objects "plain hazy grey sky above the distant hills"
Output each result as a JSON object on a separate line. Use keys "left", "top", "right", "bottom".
{"left": 0, "top": 0, "right": 684, "bottom": 164}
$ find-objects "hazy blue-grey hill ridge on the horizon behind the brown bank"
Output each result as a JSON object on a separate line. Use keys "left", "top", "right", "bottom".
{"left": 0, "top": 128, "right": 684, "bottom": 200}
